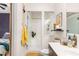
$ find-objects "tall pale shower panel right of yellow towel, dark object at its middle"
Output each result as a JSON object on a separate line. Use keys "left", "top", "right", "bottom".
{"left": 29, "top": 11, "right": 42, "bottom": 51}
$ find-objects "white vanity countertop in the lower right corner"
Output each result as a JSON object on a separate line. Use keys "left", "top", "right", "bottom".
{"left": 49, "top": 42, "right": 79, "bottom": 56}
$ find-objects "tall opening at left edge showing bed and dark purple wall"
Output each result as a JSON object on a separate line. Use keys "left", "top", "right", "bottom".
{"left": 0, "top": 3, "right": 12, "bottom": 56}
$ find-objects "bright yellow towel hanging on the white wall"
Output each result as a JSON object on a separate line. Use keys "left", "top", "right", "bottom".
{"left": 21, "top": 25, "right": 28, "bottom": 46}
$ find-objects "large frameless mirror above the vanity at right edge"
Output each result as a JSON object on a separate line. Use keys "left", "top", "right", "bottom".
{"left": 67, "top": 12, "right": 79, "bottom": 34}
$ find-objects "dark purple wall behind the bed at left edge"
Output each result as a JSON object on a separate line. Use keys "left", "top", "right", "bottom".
{"left": 0, "top": 13, "right": 10, "bottom": 38}
